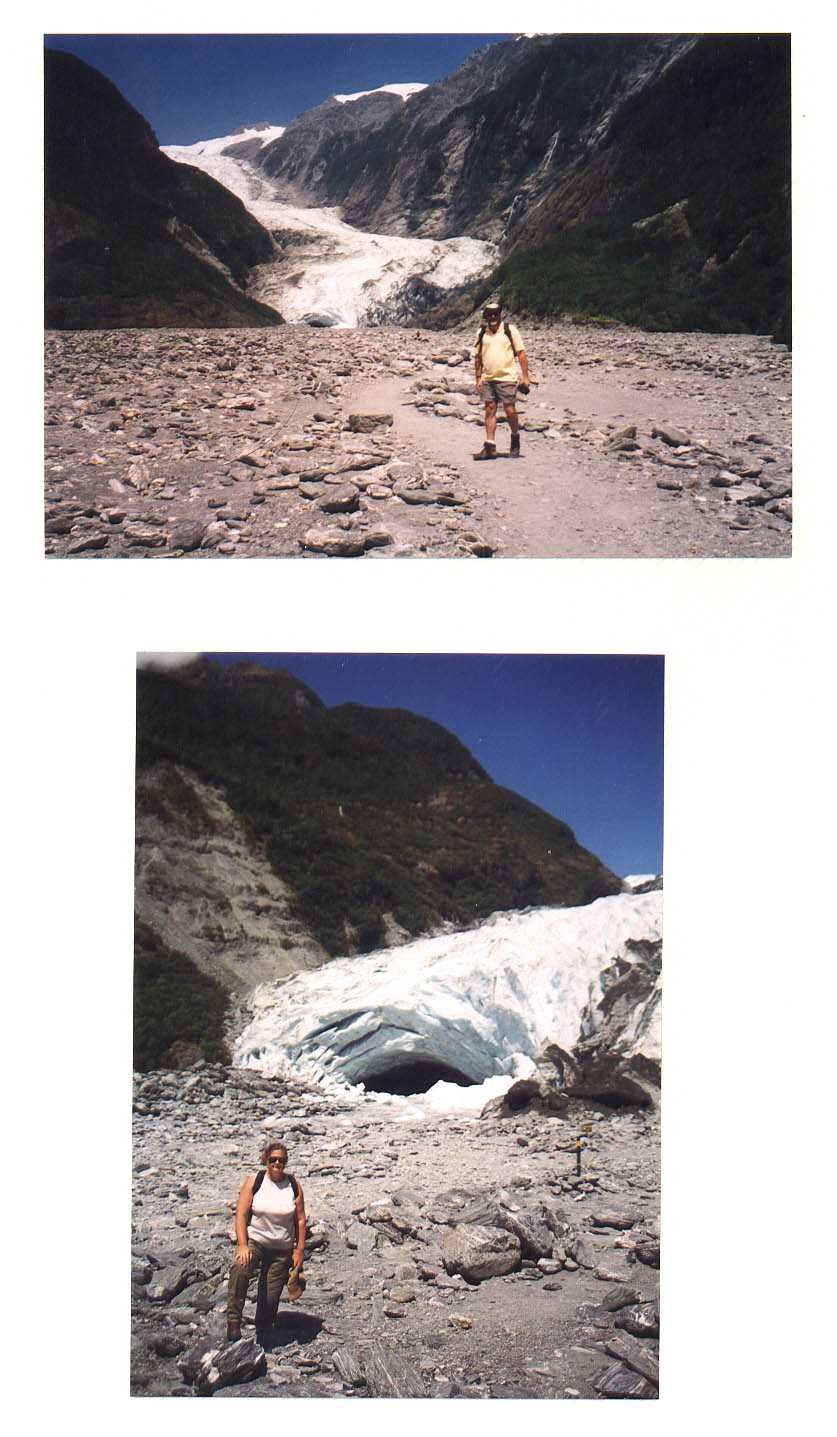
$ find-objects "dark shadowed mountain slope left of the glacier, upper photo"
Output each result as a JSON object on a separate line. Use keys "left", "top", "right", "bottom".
{"left": 45, "top": 50, "right": 282, "bottom": 329}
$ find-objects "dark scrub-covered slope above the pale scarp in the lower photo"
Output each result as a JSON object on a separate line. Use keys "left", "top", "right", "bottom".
{"left": 137, "top": 662, "right": 621, "bottom": 954}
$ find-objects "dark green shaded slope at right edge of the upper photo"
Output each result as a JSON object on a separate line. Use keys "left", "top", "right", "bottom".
{"left": 495, "top": 34, "right": 791, "bottom": 337}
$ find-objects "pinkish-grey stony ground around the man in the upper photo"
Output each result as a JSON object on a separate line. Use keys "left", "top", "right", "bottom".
{"left": 46, "top": 323, "right": 792, "bottom": 559}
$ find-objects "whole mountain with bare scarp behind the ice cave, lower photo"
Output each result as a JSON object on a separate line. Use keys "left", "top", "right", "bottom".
{"left": 137, "top": 660, "right": 621, "bottom": 1066}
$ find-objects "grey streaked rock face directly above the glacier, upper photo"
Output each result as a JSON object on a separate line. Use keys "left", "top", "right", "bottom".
{"left": 262, "top": 36, "right": 695, "bottom": 241}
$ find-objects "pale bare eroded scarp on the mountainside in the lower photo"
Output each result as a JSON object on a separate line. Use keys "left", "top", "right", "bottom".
{"left": 134, "top": 763, "right": 328, "bottom": 992}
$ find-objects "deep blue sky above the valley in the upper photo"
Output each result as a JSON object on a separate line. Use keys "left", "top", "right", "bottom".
{"left": 45, "top": 34, "right": 509, "bottom": 145}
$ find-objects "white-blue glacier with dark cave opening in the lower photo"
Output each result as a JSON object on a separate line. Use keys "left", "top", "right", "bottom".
{"left": 233, "top": 890, "right": 663, "bottom": 1108}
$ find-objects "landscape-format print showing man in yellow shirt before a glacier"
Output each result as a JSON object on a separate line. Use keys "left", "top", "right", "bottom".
{"left": 45, "top": 33, "right": 792, "bottom": 559}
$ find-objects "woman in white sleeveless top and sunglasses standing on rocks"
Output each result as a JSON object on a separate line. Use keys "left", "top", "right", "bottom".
{"left": 227, "top": 1142, "right": 305, "bottom": 1342}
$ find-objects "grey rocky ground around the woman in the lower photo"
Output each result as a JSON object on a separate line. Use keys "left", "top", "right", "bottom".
{"left": 131, "top": 1063, "right": 660, "bottom": 1400}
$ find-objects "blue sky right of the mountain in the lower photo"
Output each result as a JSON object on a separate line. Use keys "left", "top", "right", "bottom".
{"left": 201, "top": 654, "right": 663, "bottom": 875}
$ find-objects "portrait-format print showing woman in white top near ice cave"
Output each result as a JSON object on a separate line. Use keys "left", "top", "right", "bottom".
{"left": 131, "top": 652, "right": 663, "bottom": 1401}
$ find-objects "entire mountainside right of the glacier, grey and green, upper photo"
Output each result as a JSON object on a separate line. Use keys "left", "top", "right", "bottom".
{"left": 257, "top": 34, "right": 791, "bottom": 338}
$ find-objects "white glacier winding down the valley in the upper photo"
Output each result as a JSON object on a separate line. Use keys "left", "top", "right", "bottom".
{"left": 167, "top": 120, "right": 499, "bottom": 329}
